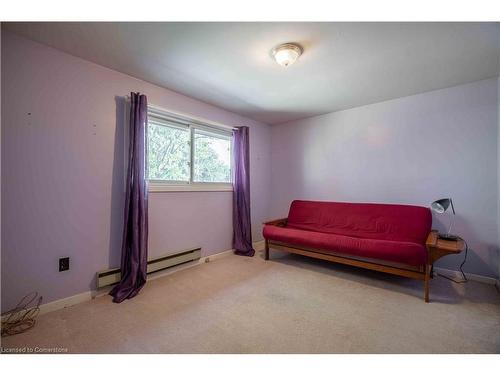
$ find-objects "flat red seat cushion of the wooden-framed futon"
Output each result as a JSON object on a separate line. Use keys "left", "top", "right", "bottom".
{"left": 263, "top": 225, "right": 427, "bottom": 266}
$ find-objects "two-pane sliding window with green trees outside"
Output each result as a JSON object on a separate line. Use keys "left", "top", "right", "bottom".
{"left": 148, "top": 108, "right": 232, "bottom": 191}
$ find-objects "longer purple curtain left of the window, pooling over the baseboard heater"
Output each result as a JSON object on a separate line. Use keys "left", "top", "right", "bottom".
{"left": 109, "top": 92, "right": 148, "bottom": 303}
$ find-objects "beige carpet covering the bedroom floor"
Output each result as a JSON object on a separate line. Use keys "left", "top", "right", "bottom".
{"left": 2, "top": 251, "right": 500, "bottom": 353}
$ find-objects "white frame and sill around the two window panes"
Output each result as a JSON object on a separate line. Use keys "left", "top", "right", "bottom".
{"left": 146, "top": 105, "right": 234, "bottom": 193}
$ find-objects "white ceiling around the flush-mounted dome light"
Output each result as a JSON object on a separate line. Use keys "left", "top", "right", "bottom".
{"left": 3, "top": 22, "right": 500, "bottom": 124}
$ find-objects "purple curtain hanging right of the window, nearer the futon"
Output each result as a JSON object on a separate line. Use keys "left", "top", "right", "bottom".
{"left": 233, "top": 126, "right": 255, "bottom": 257}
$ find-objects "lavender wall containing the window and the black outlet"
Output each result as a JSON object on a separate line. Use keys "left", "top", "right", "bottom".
{"left": 1, "top": 30, "right": 270, "bottom": 311}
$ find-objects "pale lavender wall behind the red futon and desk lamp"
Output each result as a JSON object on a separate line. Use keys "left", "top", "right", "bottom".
{"left": 270, "top": 78, "right": 499, "bottom": 276}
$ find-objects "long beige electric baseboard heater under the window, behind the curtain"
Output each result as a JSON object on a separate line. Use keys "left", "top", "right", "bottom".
{"left": 97, "top": 247, "right": 201, "bottom": 288}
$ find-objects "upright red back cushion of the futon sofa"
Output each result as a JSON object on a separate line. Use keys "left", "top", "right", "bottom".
{"left": 287, "top": 200, "right": 432, "bottom": 244}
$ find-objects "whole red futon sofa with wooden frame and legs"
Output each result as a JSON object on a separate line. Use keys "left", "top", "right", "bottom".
{"left": 263, "top": 200, "right": 434, "bottom": 302}
